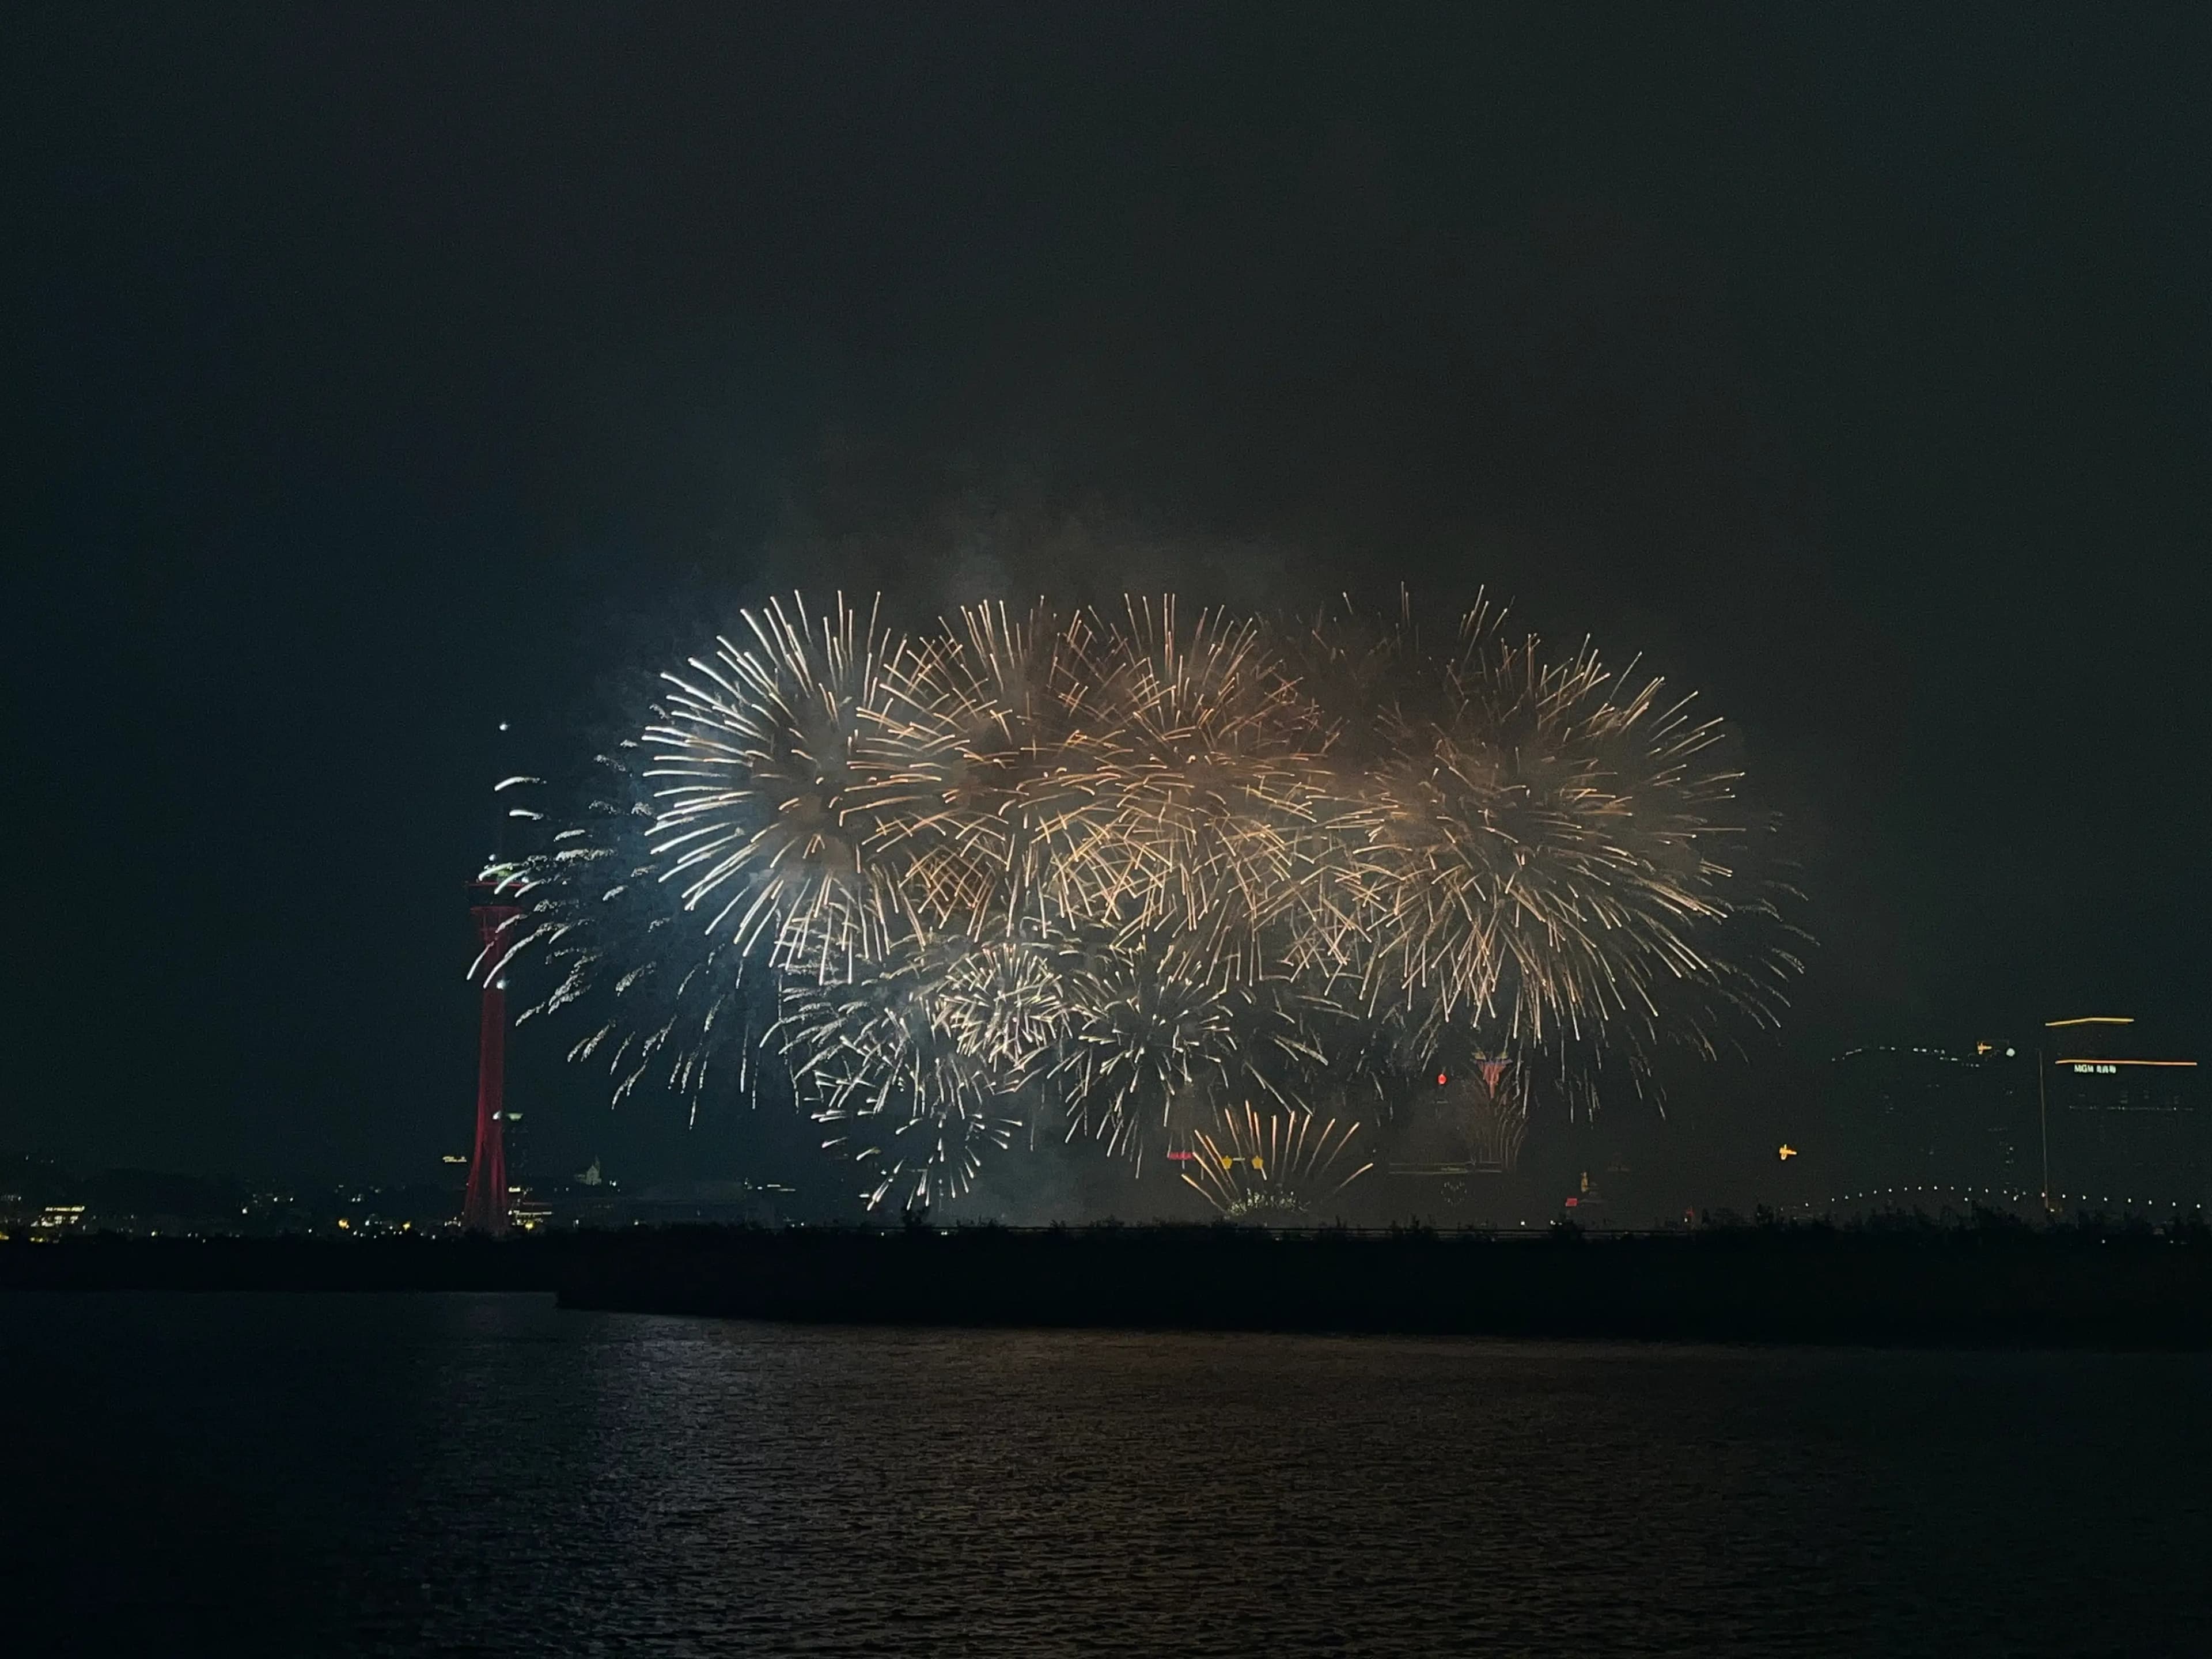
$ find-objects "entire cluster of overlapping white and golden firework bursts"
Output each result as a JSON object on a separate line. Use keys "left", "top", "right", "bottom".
{"left": 480, "top": 597, "right": 1801, "bottom": 1206}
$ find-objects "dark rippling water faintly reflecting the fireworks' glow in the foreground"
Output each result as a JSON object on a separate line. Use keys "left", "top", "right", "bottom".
{"left": 0, "top": 1294, "right": 2212, "bottom": 1654}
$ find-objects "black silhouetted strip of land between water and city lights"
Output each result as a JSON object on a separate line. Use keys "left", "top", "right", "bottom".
{"left": 17, "top": 1224, "right": 2212, "bottom": 1347}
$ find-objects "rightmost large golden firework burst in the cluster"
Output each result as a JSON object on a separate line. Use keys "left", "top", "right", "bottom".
{"left": 1292, "top": 606, "right": 1798, "bottom": 1084}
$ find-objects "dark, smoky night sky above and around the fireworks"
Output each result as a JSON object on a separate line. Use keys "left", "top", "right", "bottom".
{"left": 0, "top": 5, "right": 2212, "bottom": 1179}
